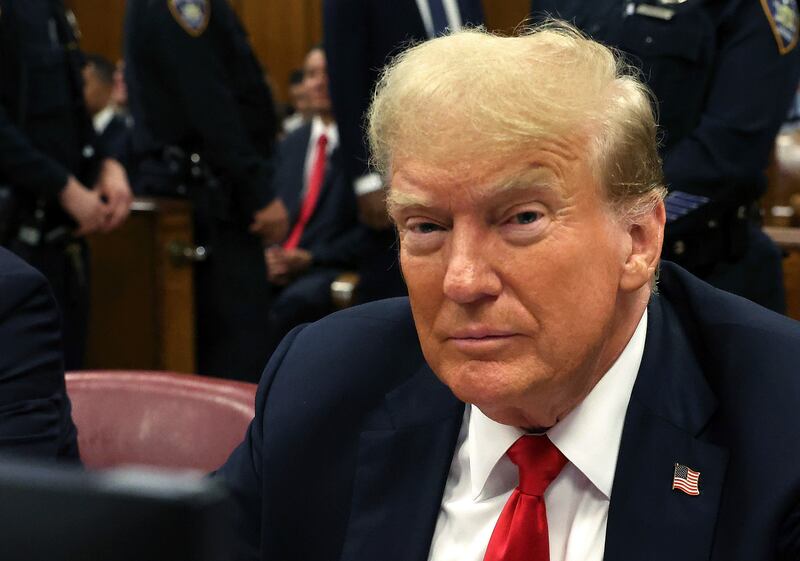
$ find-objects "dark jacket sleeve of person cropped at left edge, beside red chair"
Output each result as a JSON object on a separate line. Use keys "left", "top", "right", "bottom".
{"left": 0, "top": 248, "right": 78, "bottom": 460}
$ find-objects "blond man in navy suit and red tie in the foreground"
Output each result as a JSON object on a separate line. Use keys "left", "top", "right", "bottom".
{"left": 220, "top": 23, "right": 800, "bottom": 561}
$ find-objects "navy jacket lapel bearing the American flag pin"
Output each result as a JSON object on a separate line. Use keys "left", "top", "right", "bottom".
{"left": 605, "top": 296, "right": 728, "bottom": 561}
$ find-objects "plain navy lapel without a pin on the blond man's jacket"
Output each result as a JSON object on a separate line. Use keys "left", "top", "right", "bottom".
{"left": 342, "top": 365, "right": 464, "bottom": 561}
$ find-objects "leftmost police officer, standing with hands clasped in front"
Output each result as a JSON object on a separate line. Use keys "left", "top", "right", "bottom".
{"left": 0, "top": 0, "right": 131, "bottom": 370}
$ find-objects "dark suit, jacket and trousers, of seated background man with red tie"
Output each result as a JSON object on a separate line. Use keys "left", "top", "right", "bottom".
{"left": 269, "top": 123, "right": 374, "bottom": 348}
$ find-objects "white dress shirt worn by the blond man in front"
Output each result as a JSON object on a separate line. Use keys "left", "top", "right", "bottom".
{"left": 428, "top": 310, "right": 647, "bottom": 561}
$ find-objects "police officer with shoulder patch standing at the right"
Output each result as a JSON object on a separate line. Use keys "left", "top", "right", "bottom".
{"left": 532, "top": 0, "right": 800, "bottom": 311}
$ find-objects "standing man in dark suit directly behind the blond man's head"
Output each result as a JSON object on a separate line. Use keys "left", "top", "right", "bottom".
{"left": 323, "top": 0, "right": 483, "bottom": 302}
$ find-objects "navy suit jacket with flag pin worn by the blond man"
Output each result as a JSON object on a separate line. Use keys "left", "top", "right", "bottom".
{"left": 220, "top": 263, "right": 800, "bottom": 561}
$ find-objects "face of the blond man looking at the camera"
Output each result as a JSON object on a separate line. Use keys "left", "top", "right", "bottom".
{"left": 390, "top": 143, "right": 644, "bottom": 427}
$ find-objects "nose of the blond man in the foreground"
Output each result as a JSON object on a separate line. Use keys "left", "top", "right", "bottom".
{"left": 443, "top": 230, "right": 502, "bottom": 304}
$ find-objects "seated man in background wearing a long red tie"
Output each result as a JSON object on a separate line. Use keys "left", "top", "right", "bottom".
{"left": 266, "top": 47, "right": 371, "bottom": 349}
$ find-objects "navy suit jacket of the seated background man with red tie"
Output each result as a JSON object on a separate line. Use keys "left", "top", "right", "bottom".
{"left": 275, "top": 124, "right": 372, "bottom": 268}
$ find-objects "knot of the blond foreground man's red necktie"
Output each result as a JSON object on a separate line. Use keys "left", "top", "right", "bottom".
{"left": 508, "top": 434, "right": 567, "bottom": 497}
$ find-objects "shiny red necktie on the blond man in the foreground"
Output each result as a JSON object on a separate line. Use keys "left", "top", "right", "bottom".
{"left": 483, "top": 435, "right": 567, "bottom": 561}
